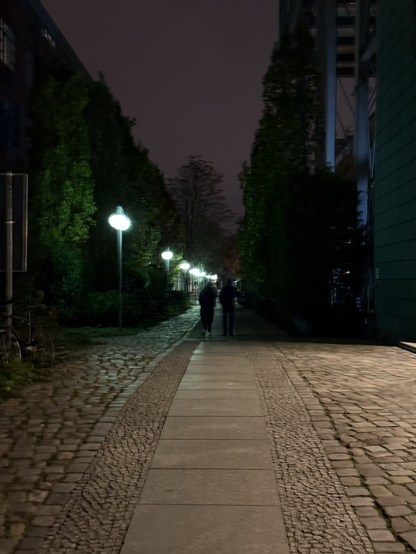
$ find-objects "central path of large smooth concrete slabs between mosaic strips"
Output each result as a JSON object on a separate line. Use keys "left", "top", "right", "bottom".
{"left": 121, "top": 342, "right": 289, "bottom": 554}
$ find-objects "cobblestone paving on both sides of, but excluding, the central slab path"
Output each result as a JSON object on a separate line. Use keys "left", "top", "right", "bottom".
{"left": 4, "top": 307, "right": 416, "bottom": 554}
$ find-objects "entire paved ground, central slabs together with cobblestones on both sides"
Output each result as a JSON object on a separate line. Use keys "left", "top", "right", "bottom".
{"left": 0, "top": 308, "right": 416, "bottom": 554}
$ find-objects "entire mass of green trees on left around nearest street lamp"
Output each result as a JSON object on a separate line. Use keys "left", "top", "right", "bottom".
{"left": 24, "top": 66, "right": 184, "bottom": 325}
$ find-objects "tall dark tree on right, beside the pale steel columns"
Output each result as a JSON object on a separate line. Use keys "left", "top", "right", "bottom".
{"left": 239, "top": 24, "right": 359, "bottom": 330}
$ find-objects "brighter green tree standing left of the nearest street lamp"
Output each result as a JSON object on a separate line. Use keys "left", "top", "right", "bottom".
{"left": 31, "top": 63, "right": 96, "bottom": 246}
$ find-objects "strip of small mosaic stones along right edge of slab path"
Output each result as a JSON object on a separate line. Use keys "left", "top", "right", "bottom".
{"left": 247, "top": 344, "right": 374, "bottom": 554}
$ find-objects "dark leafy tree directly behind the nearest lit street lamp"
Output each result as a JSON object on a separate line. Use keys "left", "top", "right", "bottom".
{"left": 85, "top": 76, "right": 178, "bottom": 291}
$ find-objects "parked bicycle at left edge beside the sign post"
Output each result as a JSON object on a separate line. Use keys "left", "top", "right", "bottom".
{"left": 0, "top": 306, "right": 55, "bottom": 367}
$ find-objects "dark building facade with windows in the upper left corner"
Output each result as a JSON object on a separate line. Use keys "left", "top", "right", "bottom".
{"left": 0, "top": 0, "right": 90, "bottom": 173}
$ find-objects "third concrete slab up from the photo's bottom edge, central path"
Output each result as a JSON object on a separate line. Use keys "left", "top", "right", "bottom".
{"left": 152, "top": 439, "right": 273, "bottom": 469}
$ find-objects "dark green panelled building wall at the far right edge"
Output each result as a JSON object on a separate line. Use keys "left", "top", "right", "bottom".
{"left": 374, "top": 0, "right": 416, "bottom": 341}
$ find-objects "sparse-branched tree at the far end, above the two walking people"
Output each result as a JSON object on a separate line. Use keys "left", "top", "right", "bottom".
{"left": 168, "top": 156, "right": 236, "bottom": 265}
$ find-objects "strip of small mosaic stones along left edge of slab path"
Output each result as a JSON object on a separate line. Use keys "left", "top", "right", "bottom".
{"left": 37, "top": 341, "right": 196, "bottom": 554}
